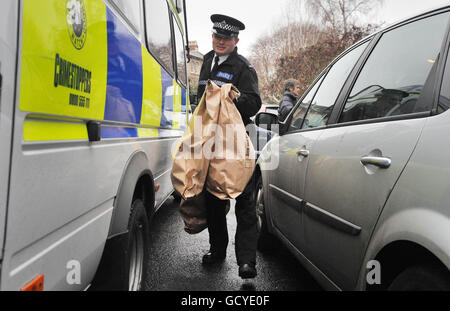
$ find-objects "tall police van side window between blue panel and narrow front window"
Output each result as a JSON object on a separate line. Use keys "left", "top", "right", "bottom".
{"left": 145, "top": 0, "right": 174, "bottom": 76}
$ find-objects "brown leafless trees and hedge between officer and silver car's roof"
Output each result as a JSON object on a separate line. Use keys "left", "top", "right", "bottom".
{"left": 250, "top": 0, "right": 383, "bottom": 104}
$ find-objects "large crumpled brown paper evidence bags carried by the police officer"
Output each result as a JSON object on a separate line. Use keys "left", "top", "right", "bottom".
{"left": 171, "top": 81, "right": 255, "bottom": 234}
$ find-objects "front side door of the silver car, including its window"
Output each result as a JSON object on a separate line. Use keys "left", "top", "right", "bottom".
{"left": 269, "top": 41, "right": 368, "bottom": 251}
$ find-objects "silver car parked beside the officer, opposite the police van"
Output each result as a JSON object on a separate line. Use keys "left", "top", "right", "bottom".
{"left": 257, "top": 6, "right": 450, "bottom": 290}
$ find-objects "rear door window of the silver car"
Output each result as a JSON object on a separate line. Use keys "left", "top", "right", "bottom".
{"left": 339, "top": 13, "right": 449, "bottom": 122}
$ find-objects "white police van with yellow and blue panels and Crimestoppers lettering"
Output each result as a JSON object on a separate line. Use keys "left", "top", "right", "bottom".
{"left": 0, "top": 0, "right": 189, "bottom": 290}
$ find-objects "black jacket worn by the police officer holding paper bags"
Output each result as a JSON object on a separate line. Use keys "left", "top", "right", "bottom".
{"left": 197, "top": 48, "right": 261, "bottom": 125}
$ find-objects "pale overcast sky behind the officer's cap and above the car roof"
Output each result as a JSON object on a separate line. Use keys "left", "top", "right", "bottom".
{"left": 186, "top": 0, "right": 450, "bottom": 57}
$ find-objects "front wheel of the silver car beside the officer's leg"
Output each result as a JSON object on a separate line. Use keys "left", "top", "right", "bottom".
{"left": 256, "top": 176, "right": 279, "bottom": 253}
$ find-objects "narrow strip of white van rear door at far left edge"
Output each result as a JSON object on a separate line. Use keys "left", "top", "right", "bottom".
{"left": 0, "top": 0, "right": 19, "bottom": 268}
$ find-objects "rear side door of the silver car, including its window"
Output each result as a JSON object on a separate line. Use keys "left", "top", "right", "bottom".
{"left": 304, "top": 13, "right": 449, "bottom": 289}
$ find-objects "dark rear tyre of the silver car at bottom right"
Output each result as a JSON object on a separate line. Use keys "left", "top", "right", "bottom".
{"left": 388, "top": 265, "right": 450, "bottom": 291}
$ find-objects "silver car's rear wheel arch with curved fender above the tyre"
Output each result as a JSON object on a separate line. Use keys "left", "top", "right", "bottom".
{"left": 357, "top": 208, "right": 450, "bottom": 290}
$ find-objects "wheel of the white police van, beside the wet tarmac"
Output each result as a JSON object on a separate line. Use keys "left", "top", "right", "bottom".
{"left": 126, "top": 199, "right": 150, "bottom": 291}
